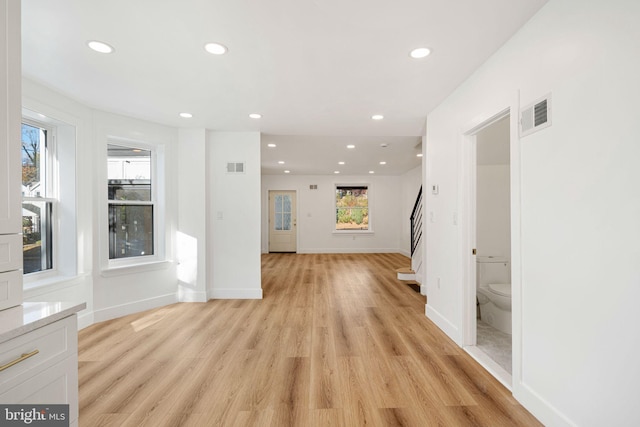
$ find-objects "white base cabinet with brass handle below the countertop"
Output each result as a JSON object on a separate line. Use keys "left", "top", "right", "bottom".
{"left": 0, "top": 314, "right": 78, "bottom": 425}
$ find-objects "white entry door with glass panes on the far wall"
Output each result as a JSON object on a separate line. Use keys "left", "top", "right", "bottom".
{"left": 269, "top": 191, "right": 297, "bottom": 252}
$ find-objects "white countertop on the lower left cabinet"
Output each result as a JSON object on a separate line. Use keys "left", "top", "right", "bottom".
{"left": 0, "top": 302, "right": 87, "bottom": 343}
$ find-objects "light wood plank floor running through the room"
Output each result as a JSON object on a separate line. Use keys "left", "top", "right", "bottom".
{"left": 79, "top": 254, "right": 540, "bottom": 427}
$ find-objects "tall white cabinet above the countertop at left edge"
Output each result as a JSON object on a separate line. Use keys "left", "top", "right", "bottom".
{"left": 0, "top": 0, "right": 22, "bottom": 310}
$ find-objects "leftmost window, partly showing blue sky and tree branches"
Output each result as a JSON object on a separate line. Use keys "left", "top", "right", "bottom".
{"left": 21, "top": 120, "right": 57, "bottom": 274}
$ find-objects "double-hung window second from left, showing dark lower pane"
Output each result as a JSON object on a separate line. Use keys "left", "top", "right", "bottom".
{"left": 107, "top": 144, "right": 156, "bottom": 260}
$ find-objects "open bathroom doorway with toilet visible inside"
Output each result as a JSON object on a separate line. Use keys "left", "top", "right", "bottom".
{"left": 463, "top": 109, "right": 513, "bottom": 389}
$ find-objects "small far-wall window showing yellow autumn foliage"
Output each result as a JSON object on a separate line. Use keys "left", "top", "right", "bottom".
{"left": 336, "top": 185, "right": 369, "bottom": 230}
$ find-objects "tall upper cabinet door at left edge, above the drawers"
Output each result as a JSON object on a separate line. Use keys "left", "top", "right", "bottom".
{"left": 0, "top": 0, "right": 22, "bottom": 234}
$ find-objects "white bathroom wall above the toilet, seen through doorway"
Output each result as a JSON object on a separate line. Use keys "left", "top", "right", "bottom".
{"left": 476, "top": 165, "right": 511, "bottom": 259}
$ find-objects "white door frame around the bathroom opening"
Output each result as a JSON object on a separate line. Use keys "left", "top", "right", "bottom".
{"left": 459, "top": 91, "right": 522, "bottom": 390}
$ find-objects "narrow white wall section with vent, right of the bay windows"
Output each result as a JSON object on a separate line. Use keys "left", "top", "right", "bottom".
{"left": 207, "top": 131, "right": 262, "bottom": 299}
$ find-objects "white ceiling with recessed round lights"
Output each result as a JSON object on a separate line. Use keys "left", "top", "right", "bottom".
{"left": 22, "top": 0, "right": 546, "bottom": 174}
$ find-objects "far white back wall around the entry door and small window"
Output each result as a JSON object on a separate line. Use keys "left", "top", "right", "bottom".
{"left": 262, "top": 175, "right": 408, "bottom": 253}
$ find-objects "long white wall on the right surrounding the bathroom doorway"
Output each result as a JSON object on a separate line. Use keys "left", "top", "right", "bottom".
{"left": 425, "top": 0, "right": 640, "bottom": 426}
